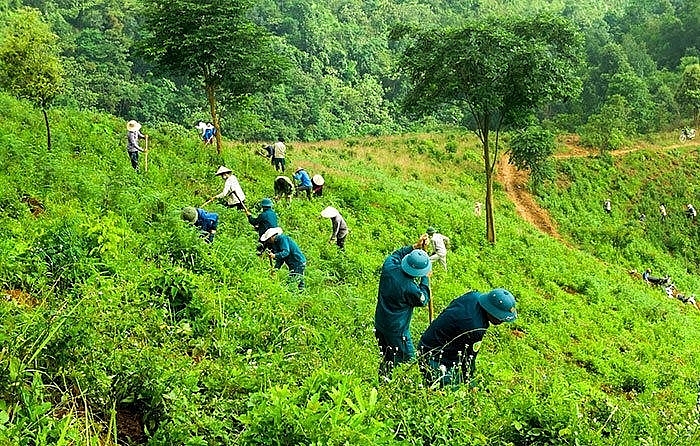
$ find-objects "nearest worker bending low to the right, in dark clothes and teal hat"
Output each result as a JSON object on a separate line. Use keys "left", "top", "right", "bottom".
{"left": 418, "top": 288, "right": 517, "bottom": 387}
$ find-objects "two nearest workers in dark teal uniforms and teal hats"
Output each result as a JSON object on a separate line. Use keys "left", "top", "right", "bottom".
{"left": 374, "top": 233, "right": 517, "bottom": 387}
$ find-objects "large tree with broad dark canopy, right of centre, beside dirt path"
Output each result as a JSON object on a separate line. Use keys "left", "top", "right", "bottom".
{"left": 401, "top": 15, "right": 583, "bottom": 243}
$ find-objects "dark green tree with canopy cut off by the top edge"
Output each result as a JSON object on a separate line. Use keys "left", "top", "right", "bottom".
{"left": 141, "top": 0, "right": 285, "bottom": 154}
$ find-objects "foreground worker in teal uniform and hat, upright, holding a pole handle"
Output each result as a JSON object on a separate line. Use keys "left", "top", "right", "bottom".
{"left": 374, "top": 234, "right": 432, "bottom": 381}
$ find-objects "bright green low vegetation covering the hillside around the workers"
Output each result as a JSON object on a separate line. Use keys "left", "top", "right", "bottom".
{"left": 0, "top": 95, "right": 700, "bottom": 445}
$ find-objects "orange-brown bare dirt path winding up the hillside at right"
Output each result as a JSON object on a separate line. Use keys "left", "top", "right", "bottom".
{"left": 496, "top": 137, "right": 686, "bottom": 241}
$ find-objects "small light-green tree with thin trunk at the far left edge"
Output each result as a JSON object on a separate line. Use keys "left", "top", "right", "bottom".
{"left": 0, "top": 8, "right": 64, "bottom": 151}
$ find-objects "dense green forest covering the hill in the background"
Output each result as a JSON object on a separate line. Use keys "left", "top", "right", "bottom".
{"left": 0, "top": 0, "right": 700, "bottom": 141}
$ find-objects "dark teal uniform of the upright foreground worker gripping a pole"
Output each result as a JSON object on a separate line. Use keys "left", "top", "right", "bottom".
{"left": 374, "top": 246, "right": 430, "bottom": 357}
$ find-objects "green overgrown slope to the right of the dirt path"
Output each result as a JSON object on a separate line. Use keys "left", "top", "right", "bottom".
{"left": 539, "top": 143, "right": 700, "bottom": 293}
